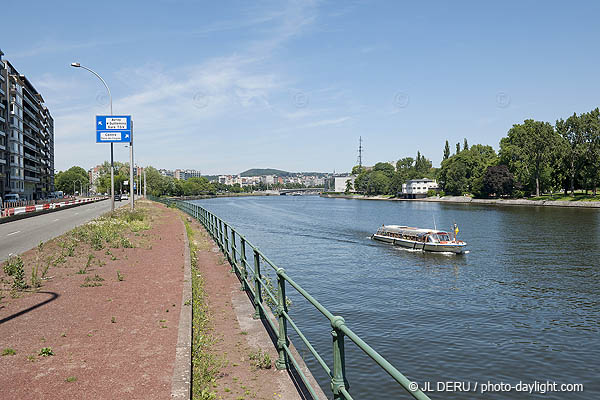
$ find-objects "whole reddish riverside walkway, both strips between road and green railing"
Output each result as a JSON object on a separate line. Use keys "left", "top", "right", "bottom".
{"left": 0, "top": 201, "right": 301, "bottom": 400}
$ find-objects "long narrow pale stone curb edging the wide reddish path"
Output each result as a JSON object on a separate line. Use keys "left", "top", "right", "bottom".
{"left": 171, "top": 221, "right": 192, "bottom": 399}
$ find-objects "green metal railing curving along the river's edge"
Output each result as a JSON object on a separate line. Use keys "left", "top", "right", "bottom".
{"left": 151, "top": 197, "right": 429, "bottom": 400}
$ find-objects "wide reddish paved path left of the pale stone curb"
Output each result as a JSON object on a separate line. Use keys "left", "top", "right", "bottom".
{"left": 0, "top": 204, "right": 190, "bottom": 400}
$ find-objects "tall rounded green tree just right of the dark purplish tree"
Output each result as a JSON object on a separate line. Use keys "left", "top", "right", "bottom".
{"left": 500, "top": 119, "right": 557, "bottom": 196}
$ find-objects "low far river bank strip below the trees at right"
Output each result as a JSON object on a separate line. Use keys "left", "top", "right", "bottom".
{"left": 321, "top": 194, "right": 600, "bottom": 208}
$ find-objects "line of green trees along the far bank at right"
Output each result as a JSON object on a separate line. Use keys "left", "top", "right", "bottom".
{"left": 347, "top": 108, "right": 600, "bottom": 197}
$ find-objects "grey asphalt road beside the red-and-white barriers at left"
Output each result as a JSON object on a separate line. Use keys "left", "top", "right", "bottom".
{"left": 0, "top": 200, "right": 119, "bottom": 262}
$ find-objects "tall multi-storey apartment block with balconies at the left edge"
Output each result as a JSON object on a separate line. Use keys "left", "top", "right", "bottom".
{"left": 0, "top": 51, "right": 54, "bottom": 200}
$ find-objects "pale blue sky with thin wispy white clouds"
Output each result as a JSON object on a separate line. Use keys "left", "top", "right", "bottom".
{"left": 0, "top": 0, "right": 600, "bottom": 174}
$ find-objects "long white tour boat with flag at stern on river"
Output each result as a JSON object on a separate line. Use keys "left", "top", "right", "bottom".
{"left": 371, "top": 224, "right": 467, "bottom": 254}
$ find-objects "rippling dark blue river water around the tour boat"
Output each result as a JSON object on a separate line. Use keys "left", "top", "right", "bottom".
{"left": 191, "top": 196, "right": 600, "bottom": 399}
